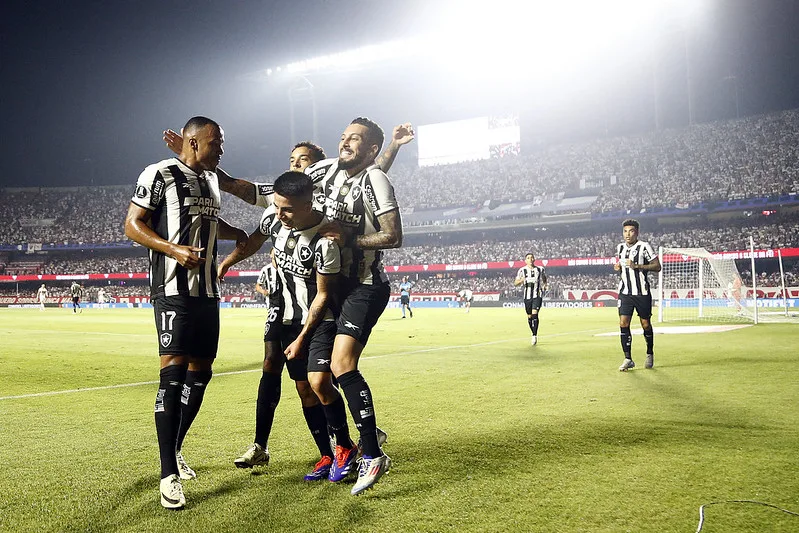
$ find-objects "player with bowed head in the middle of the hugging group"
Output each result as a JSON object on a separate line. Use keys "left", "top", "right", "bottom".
{"left": 219, "top": 171, "right": 353, "bottom": 482}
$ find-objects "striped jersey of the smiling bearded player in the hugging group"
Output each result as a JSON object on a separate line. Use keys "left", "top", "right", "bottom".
{"left": 305, "top": 159, "right": 399, "bottom": 285}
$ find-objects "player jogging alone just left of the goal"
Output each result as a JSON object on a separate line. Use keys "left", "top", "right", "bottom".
{"left": 613, "top": 218, "right": 660, "bottom": 372}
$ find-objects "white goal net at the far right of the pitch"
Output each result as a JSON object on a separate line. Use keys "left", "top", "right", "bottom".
{"left": 658, "top": 248, "right": 756, "bottom": 323}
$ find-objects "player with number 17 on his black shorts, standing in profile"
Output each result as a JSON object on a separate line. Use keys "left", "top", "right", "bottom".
{"left": 125, "top": 116, "right": 247, "bottom": 509}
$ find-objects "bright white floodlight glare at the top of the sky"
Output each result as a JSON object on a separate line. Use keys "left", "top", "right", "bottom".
{"left": 267, "top": 0, "right": 713, "bottom": 79}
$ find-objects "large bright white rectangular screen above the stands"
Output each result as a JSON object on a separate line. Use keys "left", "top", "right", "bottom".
{"left": 418, "top": 115, "right": 521, "bottom": 167}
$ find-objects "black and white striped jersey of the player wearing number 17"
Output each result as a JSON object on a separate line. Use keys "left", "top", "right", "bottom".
{"left": 131, "top": 157, "right": 220, "bottom": 298}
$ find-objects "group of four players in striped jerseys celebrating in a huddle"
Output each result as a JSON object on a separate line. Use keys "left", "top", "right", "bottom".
{"left": 125, "top": 117, "right": 414, "bottom": 509}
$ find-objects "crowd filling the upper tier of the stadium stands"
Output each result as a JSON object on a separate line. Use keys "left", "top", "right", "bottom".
{"left": 0, "top": 110, "right": 799, "bottom": 244}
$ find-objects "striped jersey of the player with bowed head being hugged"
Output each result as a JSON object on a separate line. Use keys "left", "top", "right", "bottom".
{"left": 259, "top": 206, "right": 341, "bottom": 324}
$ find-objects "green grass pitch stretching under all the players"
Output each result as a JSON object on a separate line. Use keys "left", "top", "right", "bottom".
{"left": 0, "top": 308, "right": 799, "bottom": 533}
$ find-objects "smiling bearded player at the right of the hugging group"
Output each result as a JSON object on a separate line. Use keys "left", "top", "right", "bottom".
{"left": 305, "top": 117, "right": 402, "bottom": 494}
